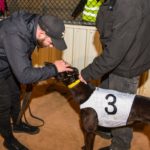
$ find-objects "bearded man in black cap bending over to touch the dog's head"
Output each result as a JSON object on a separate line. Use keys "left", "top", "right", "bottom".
{"left": 0, "top": 11, "right": 71, "bottom": 150}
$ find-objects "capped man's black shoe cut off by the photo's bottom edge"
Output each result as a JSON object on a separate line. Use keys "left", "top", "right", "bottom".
{"left": 3, "top": 136, "right": 29, "bottom": 150}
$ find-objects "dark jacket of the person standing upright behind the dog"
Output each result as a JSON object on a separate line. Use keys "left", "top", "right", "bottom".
{"left": 81, "top": 0, "right": 150, "bottom": 80}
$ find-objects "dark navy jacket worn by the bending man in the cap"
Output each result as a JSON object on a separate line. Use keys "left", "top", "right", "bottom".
{"left": 0, "top": 11, "right": 57, "bottom": 83}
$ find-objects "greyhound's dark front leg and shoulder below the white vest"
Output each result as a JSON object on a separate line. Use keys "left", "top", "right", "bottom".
{"left": 81, "top": 108, "right": 98, "bottom": 150}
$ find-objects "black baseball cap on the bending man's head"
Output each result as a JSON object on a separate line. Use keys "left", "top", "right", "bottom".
{"left": 38, "top": 15, "right": 67, "bottom": 50}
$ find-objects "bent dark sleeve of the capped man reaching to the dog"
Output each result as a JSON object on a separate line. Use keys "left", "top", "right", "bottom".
{"left": 3, "top": 33, "right": 57, "bottom": 84}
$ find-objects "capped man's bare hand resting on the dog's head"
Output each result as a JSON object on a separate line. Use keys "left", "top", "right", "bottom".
{"left": 54, "top": 60, "right": 73, "bottom": 72}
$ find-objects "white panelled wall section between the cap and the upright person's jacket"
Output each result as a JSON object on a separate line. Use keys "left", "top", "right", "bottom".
{"left": 63, "top": 25, "right": 101, "bottom": 70}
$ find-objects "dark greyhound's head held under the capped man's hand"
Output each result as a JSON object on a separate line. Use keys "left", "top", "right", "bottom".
{"left": 56, "top": 67, "right": 79, "bottom": 86}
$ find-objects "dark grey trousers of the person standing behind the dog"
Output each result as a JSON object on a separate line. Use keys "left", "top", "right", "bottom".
{"left": 100, "top": 74, "right": 139, "bottom": 150}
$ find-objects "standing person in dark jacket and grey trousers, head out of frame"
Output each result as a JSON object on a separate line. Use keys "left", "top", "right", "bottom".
{"left": 79, "top": 0, "right": 150, "bottom": 150}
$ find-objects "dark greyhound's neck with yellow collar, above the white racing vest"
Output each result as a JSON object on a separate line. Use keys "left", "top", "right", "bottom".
{"left": 68, "top": 80, "right": 95, "bottom": 104}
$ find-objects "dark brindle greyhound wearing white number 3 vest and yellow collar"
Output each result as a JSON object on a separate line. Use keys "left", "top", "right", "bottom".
{"left": 57, "top": 68, "right": 150, "bottom": 150}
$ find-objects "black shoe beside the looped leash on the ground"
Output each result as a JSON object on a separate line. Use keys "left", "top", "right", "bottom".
{"left": 13, "top": 122, "right": 40, "bottom": 134}
